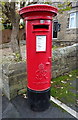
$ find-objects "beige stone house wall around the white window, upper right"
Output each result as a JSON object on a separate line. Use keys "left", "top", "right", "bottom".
{"left": 53, "top": 2, "right": 78, "bottom": 46}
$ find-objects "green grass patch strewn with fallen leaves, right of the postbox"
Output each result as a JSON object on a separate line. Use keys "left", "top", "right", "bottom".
{"left": 51, "top": 70, "right": 78, "bottom": 103}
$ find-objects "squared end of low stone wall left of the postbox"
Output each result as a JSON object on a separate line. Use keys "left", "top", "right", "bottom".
{"left": 2, "top": 62, "right": 27, "bottom": 100}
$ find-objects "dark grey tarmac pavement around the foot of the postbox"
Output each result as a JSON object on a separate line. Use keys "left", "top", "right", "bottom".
{"left": 2, "top": 96, "right": 77, "bottom": 120}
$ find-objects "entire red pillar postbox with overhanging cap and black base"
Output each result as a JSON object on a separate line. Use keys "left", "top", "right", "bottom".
{"left": 19, "top": 4, "right": 57, "bottom": 111}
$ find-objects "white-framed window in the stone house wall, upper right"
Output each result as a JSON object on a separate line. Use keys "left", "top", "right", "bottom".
{"left": 69, "top": 12, "right": 78, "bottom": 28}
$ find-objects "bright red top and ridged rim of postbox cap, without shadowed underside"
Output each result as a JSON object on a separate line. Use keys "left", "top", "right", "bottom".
{"left": 19, "top": 4, "right": 58, "bottom": 16}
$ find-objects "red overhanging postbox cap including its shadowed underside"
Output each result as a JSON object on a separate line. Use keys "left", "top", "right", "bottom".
{"left": 19, "top": 4, "right": 58, "bottom": 18}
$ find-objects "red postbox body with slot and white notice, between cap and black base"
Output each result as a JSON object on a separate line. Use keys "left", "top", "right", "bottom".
{"left": 27, "top": 21, "right": 52, "bottom": 91}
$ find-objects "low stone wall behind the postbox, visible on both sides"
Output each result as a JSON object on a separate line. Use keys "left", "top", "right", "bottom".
{"left": 3, "top": 44, "right": 78, "bottom": 99}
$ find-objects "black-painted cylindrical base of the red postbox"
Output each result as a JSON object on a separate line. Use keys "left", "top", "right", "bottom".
{"left": 27, "top": 88, "right": 50, "bottom": 111}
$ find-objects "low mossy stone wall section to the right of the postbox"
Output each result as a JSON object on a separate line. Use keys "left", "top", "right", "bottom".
{"left": 52, "top": 44, "right": 78, "bottom": 78}
